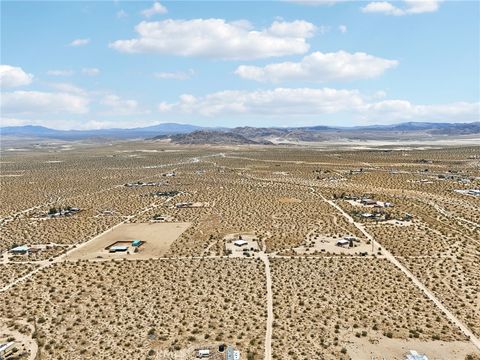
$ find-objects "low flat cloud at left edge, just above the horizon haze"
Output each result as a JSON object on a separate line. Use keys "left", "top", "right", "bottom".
{"left": 1, "top": 91, "right": 89, "bottom": 114}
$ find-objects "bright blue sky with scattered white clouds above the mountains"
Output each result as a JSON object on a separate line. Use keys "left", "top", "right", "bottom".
{"left": 1, "top": 0, "right": 480, "bottom": 129}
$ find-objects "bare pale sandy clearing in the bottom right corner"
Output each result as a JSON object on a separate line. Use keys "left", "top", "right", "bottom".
{"left": 346, "top": 336, "right": 478, "bottom": 360}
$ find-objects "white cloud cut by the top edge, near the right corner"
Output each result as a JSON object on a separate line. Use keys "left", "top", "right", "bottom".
{"left": 362, "top": 0, "right": 440, "bottom": 16}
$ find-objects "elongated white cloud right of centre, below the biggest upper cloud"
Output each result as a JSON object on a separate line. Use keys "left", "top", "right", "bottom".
{"left": 235, "top": 51, "right": 398, "bottom": 82}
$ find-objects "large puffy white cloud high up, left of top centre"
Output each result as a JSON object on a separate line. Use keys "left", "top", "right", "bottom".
{"left": 110, "top": 19, "right": 317, "bottom": 60}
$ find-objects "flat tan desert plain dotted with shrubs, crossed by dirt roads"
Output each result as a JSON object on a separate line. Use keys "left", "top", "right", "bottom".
{"left": 0, "top": 141, "right": 480, "bottom": 360}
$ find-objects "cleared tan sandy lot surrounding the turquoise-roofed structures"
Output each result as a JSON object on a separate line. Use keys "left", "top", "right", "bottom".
{"left": 66, "top": 223, "right": 190, "bottom": 260}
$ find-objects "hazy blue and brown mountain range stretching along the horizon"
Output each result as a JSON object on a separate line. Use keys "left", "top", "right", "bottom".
{"left": 0, "top": 122, "right": 480, "bottom": 144}
